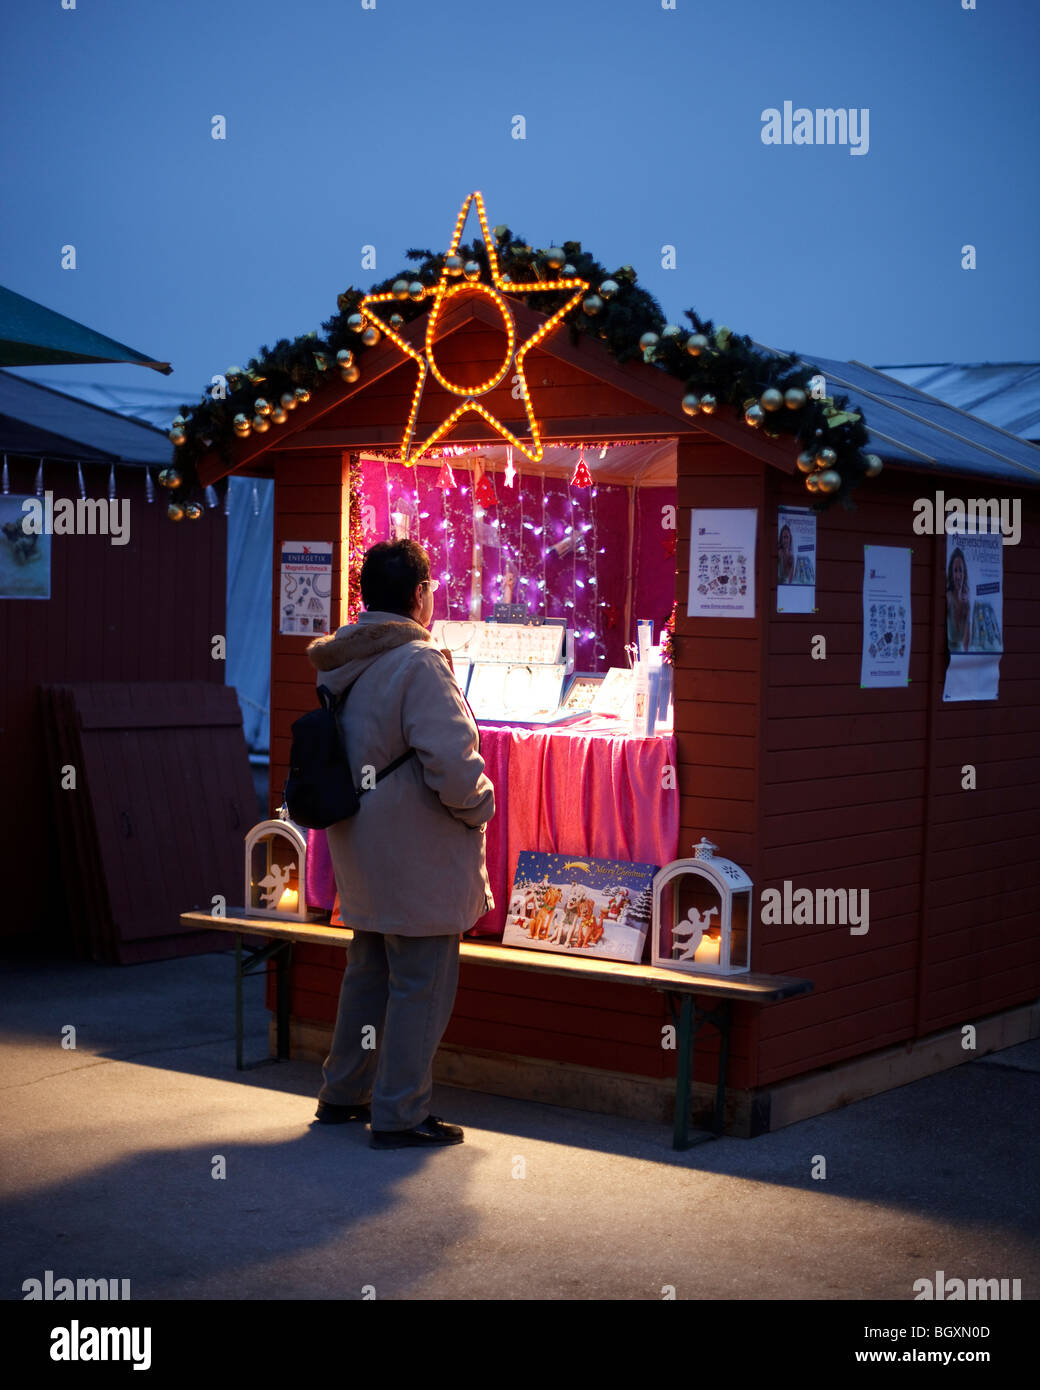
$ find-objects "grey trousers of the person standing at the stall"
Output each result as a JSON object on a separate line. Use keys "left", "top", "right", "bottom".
{"left": 318, "top": 931, "right": 459, "bottom": 1130}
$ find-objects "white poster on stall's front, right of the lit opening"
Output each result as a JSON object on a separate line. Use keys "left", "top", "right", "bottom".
{"left": 687, "top": 507, "right": 758, "bottom": 617}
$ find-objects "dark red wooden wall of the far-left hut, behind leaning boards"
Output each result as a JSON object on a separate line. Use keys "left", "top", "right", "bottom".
{"left": 0, "top": 459, "right": 227, "bottom": 941}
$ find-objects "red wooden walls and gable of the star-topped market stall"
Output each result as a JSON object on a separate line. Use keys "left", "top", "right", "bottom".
{"left": 199, "top": 233, "right": 1040, "bottom": 1133}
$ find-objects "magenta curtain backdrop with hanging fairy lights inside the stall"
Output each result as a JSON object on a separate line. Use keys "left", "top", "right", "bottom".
{"left": 361, "top": 455, "right": 676, "bottom": 671}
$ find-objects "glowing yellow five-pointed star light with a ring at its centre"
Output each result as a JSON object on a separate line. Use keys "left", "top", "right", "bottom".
{"left": 359, "top": 192, "right": 588, "bottom": 467}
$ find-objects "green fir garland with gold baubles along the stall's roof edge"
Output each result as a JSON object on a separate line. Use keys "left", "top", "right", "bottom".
{"left": 170, "top": 227, "right": 880, "bottom": 510}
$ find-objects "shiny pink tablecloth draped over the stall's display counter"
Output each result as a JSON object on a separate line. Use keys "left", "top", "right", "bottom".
{"left": 307, "top": 721, "right": 679, "bottom": 937}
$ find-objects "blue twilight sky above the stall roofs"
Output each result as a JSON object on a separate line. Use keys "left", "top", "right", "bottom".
{"left": 0, "top": 0, "right": 1040, "bottom": 402}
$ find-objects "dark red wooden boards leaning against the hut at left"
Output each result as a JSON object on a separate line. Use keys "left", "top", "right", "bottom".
{"left": 40, "top": 681, "right": 257, "bottom": 965}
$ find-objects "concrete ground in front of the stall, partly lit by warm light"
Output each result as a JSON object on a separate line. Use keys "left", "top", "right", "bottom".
{"left": 0, "top": 954, "right": 1040, "bottom": 1300}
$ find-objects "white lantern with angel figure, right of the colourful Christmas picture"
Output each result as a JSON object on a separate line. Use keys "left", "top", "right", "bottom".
{"left": 652, "top": 837, "right": 754, "bottom": 974}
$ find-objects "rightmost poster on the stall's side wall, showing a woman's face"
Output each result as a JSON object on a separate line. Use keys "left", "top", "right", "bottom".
{"left": 943, "top": 523, "right": 1004, "bottom": 701}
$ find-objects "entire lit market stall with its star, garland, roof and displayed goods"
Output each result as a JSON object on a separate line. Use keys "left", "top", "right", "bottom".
{"left": 164, "top": 195, "right": 1040, "bottom": 1133}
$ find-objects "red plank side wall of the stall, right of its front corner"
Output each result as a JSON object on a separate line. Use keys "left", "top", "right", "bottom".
{"left": 754, "top": 470, "right": 1040, "bottom": 1086}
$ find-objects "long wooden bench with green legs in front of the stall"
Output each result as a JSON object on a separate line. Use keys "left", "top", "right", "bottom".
{"left": 181, "top": 909, "right": 812, "bottom": 1150}
